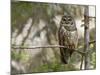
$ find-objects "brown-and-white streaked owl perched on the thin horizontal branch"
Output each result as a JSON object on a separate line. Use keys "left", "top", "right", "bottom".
{"left": 58, "top": 15, "right": 78, "bottom": 64}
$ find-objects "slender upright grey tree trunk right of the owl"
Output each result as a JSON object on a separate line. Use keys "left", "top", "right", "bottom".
{"left": 84, "top": 6, "right": 90, "bottom": 70}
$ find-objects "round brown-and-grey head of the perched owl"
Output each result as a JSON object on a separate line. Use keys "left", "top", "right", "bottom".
{"left": 60, "top": 15, "right": 76, "bottom": 31}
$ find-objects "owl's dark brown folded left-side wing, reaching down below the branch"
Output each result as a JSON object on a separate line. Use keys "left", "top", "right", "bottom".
{"left": 58, "top": 29, "right": 70, "bottom": 64}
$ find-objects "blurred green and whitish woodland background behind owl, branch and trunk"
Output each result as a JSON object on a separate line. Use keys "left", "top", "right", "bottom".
{"left": 11, "top": 1, "right": 96, "bottom": 74}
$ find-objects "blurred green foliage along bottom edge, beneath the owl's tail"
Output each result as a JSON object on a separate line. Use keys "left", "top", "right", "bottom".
{"left": 33, "top": 63, "right": 78, "bottom": 72}
